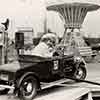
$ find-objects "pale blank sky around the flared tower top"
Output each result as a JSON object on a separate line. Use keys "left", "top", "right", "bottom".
{"left": 0, "top": 0, "right": 100, "bottom": 38}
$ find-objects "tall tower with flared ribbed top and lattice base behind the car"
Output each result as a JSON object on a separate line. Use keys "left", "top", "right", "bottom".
{"left": 47, "top": 0, "right": 100, "bottom": 56}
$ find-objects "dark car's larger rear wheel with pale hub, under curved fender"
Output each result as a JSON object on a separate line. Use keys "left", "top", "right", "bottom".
{"left": 18, "top": 76, "right": 37, "bottom": 100}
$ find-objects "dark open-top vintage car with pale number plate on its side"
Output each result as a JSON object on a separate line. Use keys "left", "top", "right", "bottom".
{"left": 0, "top": 55, "right": 87, "bottom": 100}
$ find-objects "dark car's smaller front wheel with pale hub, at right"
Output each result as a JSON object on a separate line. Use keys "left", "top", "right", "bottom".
{"left": 73, "top": 64, "right": 87, "bottom": 80}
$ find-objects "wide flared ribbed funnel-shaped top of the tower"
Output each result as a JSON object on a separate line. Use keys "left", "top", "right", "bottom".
{"left": 47, "top": 3, "right": 100, "bottom": 29}
